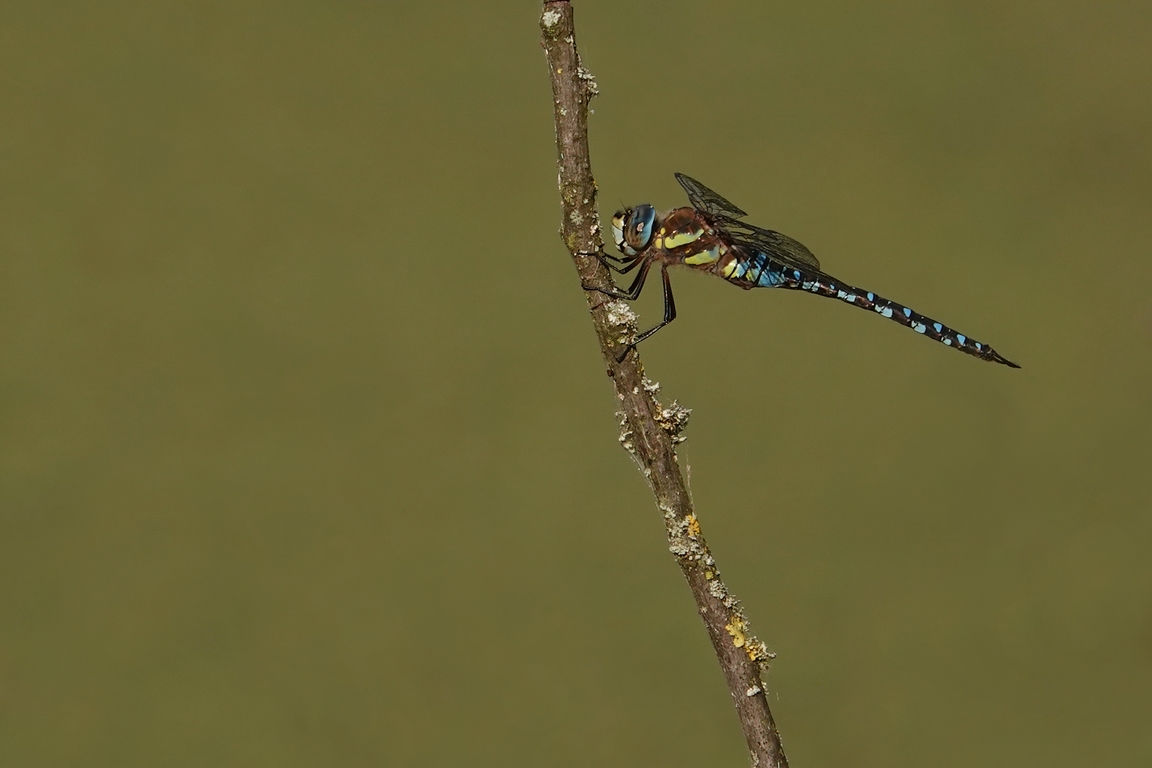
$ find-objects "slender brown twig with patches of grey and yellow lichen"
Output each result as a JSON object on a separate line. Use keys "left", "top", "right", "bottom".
{"left": 540, "top": 0, "right": 788, "bottom": 768}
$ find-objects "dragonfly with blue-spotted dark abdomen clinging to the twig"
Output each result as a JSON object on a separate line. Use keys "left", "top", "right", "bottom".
{"left": 584, "top": 173, "right": 1020, "bottom": 368}
